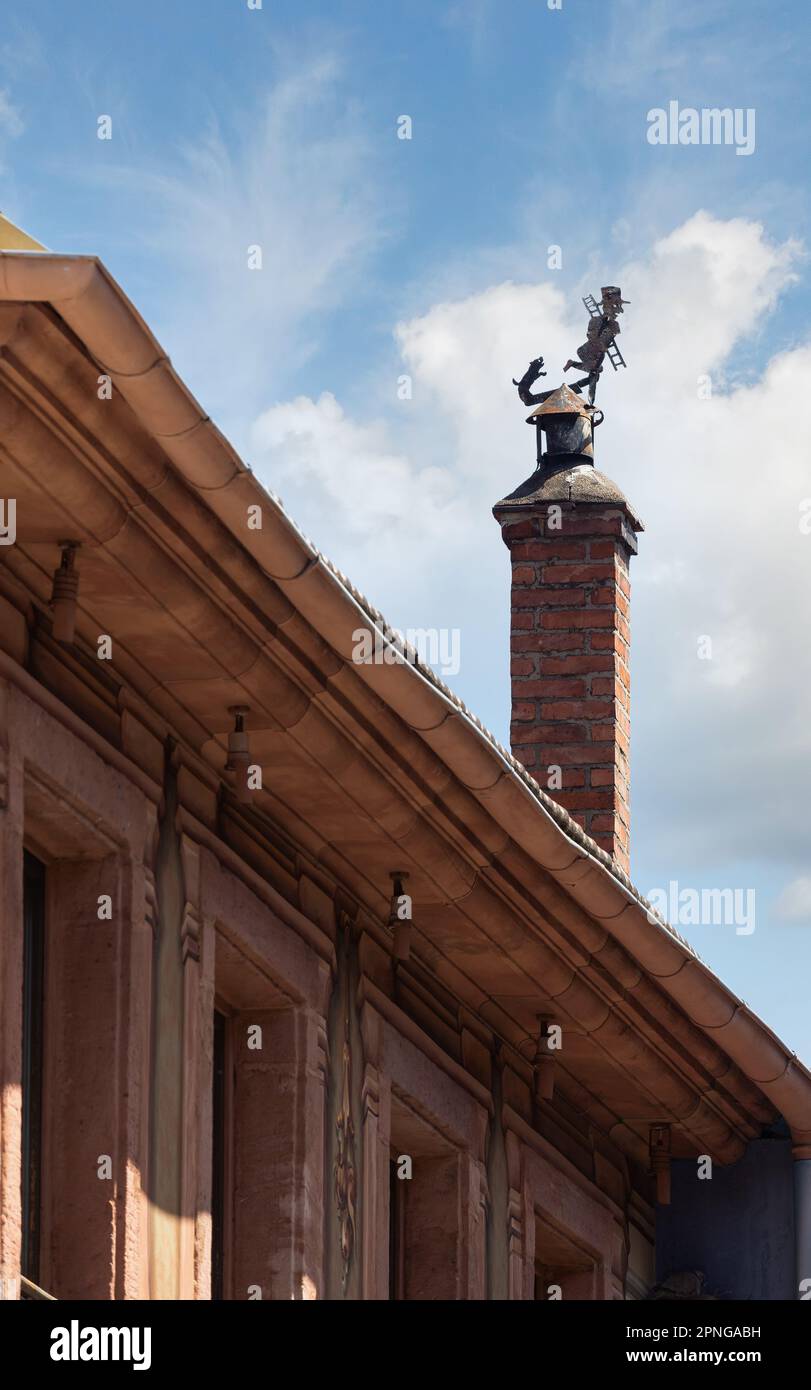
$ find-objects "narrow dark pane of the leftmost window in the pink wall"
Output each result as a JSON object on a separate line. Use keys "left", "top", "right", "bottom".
{"left": 21, "top": 851, "right": 45, "bottom": 1283}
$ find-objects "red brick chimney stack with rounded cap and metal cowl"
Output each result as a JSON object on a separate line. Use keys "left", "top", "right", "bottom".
{"left": 492, "top": 386, "right": 643, "bottom": 873}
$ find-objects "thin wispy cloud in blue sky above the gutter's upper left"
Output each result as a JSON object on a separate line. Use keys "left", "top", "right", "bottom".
{"left": 95, "top": 53, "right": 383, "bottom": 435}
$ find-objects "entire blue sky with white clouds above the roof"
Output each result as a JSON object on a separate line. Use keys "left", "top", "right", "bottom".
{"left": 6, "top": 0, "right": 811, "bottom": 1065}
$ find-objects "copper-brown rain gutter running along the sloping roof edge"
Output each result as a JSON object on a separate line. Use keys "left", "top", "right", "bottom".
{"left": 0, "top": 252, "right": 811, "bottom": 1158}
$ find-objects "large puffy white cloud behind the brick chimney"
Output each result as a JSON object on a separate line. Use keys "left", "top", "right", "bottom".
{"left": 255, "top": 213, "right": 811, "bottom": 862}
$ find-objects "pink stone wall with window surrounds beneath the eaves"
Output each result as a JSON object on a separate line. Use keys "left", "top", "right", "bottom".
{"left": 0, "top": 674, "right": 651, "bottom": 1300}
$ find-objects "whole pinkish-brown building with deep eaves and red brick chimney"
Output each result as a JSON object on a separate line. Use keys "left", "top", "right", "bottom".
{"left": 0, "top": 250, "right": 811, "bottom": 1300}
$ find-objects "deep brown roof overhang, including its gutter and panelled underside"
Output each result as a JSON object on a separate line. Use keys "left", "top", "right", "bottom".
{"left": 0, "top": 253, "right": 811, "bottom": 1162}
